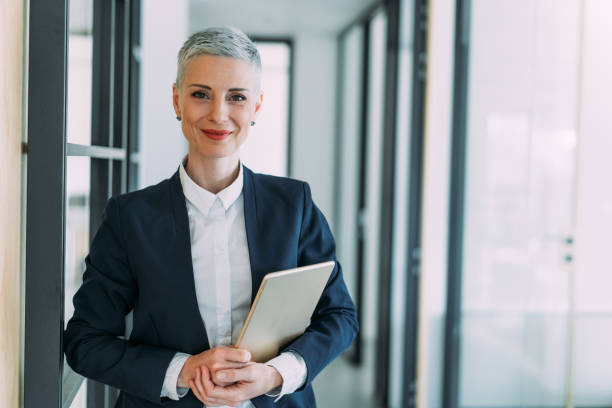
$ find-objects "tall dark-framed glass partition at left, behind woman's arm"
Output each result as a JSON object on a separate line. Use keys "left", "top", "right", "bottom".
{"left": 24, "top": 0, "right": 140, "bottom": 408}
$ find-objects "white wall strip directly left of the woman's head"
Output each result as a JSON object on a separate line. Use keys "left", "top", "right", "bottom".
{"left": 139, "top": 0, "right": 189, "bottom": 187}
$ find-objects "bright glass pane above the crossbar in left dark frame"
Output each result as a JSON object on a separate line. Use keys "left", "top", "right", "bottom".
{"left": 66, "top": 0, "right": 93, "bottom": 145}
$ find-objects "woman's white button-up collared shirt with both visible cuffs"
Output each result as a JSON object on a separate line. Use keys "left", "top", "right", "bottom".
{"left": 161, "top": 159, "right": 307, "bottom": 408}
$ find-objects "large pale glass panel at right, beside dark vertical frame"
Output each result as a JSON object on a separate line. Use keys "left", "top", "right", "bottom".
{"left": 459, "top": 0, "right": 580, "bottom": 407}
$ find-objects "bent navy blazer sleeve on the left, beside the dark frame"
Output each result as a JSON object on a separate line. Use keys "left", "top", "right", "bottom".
{"left": 64, "top": 198, "right": 175, "bottom": 404}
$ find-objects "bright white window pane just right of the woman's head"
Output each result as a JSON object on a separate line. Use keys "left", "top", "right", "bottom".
{"left": 240, "top": 42, "right": 291, "bottom": 176}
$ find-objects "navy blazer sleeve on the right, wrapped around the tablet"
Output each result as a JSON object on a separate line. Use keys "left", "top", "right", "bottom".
{"left": 285, "top": 183, "right": 359, "bottom": 391}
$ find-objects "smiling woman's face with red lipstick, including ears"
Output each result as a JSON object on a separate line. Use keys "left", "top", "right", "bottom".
{"left": 172, "top": 55, "right": 263, "bottom": 159}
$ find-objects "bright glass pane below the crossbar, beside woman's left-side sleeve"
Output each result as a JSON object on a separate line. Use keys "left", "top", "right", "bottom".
{"left": 64, "top": 156, "right": 90, "bottom": 325}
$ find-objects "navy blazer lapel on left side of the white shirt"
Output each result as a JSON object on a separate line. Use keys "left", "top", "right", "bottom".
{"left": 170, "top": 171, "right": 210, "bottom": 353}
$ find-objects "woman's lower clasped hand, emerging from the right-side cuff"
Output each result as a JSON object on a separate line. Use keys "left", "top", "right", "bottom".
{"left": 189, "top": 363, "right": 283, "bottom": 407}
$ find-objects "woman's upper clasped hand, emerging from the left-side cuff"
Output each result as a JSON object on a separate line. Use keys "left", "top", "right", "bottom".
{"left": 177, "top": 346, "right": 251, "bottom": 387}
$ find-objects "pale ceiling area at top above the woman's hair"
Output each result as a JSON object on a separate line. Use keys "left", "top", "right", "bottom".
{"left": 189, "top": 0, "right": 379, "bottom": 37}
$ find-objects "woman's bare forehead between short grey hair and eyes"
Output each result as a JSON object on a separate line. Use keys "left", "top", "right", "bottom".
{"left": 183, "top": 55, "right": 257, "bottom": 89}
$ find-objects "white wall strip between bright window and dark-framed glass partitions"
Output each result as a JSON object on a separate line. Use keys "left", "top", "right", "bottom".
{"left": 290, "top": 33, "right": 337, "bottom": 228}
